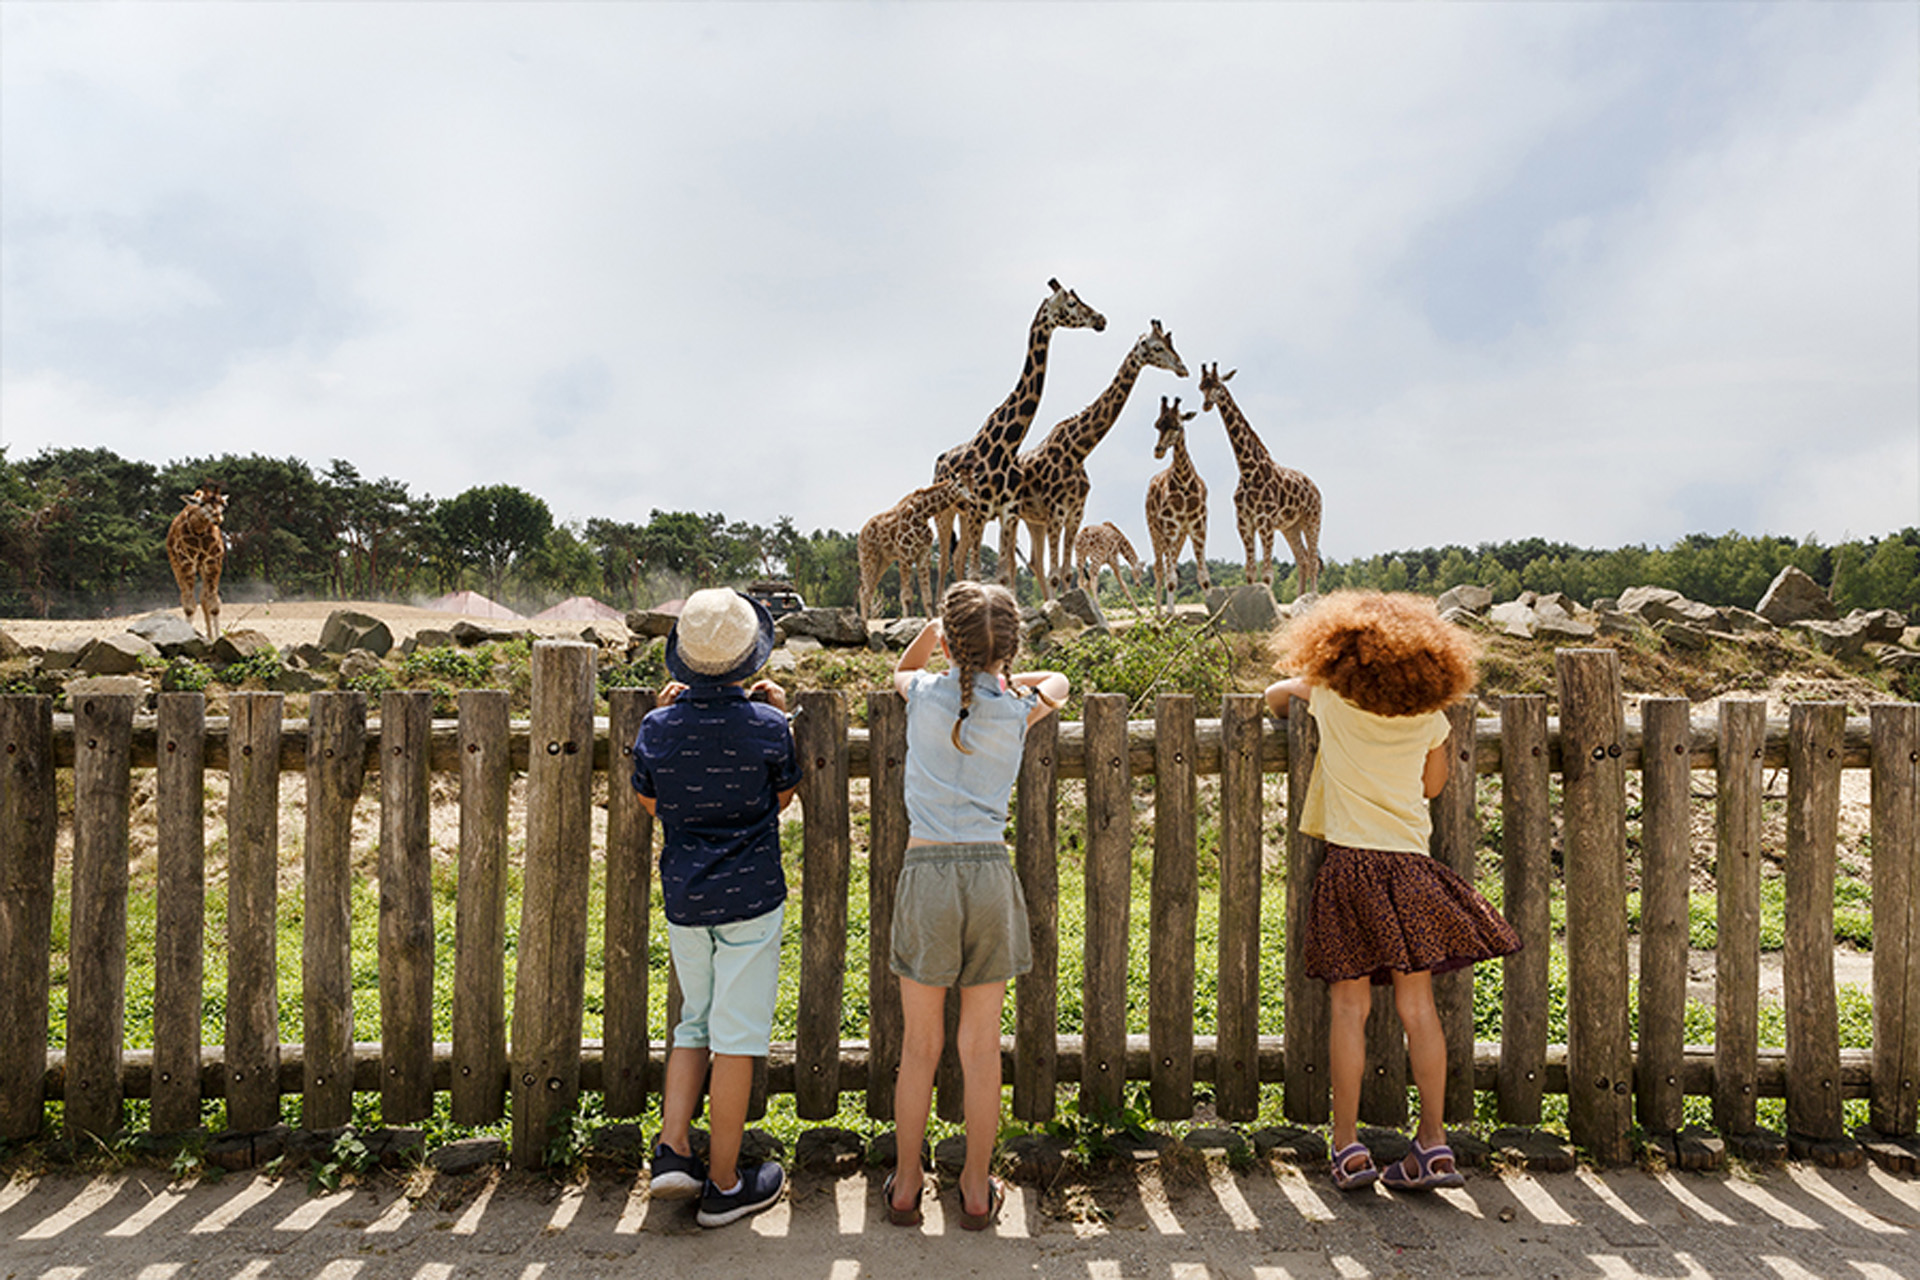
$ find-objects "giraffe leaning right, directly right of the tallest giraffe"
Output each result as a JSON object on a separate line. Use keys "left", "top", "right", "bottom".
{"left": 1020, "top": 320, "right": 1187, "bottom": 599}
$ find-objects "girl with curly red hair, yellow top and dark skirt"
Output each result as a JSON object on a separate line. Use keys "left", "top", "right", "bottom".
{"left": 1267, "top": 591, "right": 1521, "bottom": 1192}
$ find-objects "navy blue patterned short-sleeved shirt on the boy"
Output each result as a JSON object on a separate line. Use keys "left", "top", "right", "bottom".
{"left": 634, "top": 685, "right": 801, "bottom": 925}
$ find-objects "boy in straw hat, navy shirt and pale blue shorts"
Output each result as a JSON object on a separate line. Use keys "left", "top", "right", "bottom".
{"left": 634, "top": 587, "right": 801, "bottom": 1226}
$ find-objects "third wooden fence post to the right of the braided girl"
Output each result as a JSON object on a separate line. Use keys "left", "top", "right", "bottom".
{"left": 1146, "top": 693, "right": 1190, "bottom": 1121}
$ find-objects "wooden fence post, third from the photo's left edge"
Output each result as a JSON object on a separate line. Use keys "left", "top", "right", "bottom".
{"left": 153, "top": 693, "right": 207, "bottom": 1134}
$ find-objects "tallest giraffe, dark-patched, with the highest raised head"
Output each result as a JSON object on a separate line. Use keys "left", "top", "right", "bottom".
{"left": 933, "top": 280, "right": 1106, "bottom": 585}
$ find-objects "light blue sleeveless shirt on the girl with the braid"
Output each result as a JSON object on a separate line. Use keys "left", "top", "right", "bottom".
{"left": 906, "top": 670, "right": 1033, "bottom": 844}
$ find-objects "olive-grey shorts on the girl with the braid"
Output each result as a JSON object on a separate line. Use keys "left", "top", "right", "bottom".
{"left": 887, "top": 844, "right": 1033, "bottom": 986}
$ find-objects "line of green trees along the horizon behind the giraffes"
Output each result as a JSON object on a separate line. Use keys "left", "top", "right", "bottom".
{"left": 0, "top": 449, "right": 1920, "bottom": 618}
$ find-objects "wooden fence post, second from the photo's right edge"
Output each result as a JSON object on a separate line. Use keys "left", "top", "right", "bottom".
{"left": 1782, "top": 702, "right": 1851, "bottom": 1155}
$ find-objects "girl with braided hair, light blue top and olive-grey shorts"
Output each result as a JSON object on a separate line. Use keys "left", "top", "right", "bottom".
{"left": 885, "top": 581, "right": 1068, "bottom": 1230}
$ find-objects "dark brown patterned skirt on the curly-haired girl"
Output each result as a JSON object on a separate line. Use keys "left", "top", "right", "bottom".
{"left": 1302, "top": 844, "right": 1521, "bottom": 986}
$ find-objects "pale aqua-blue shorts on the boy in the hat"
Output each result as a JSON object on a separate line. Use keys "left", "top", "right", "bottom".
{"left": 666, "top": 902, "right": 787, "bottom": 1057}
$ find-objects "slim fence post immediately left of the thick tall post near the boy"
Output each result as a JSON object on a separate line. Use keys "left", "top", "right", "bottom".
{"left": 453, "top": 689, "right": 510, "bottom": 1125}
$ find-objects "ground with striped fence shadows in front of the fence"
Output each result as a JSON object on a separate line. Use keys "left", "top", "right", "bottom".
{"left": 0, "top": 1163, "right": 1920, "bottom": 1280}
